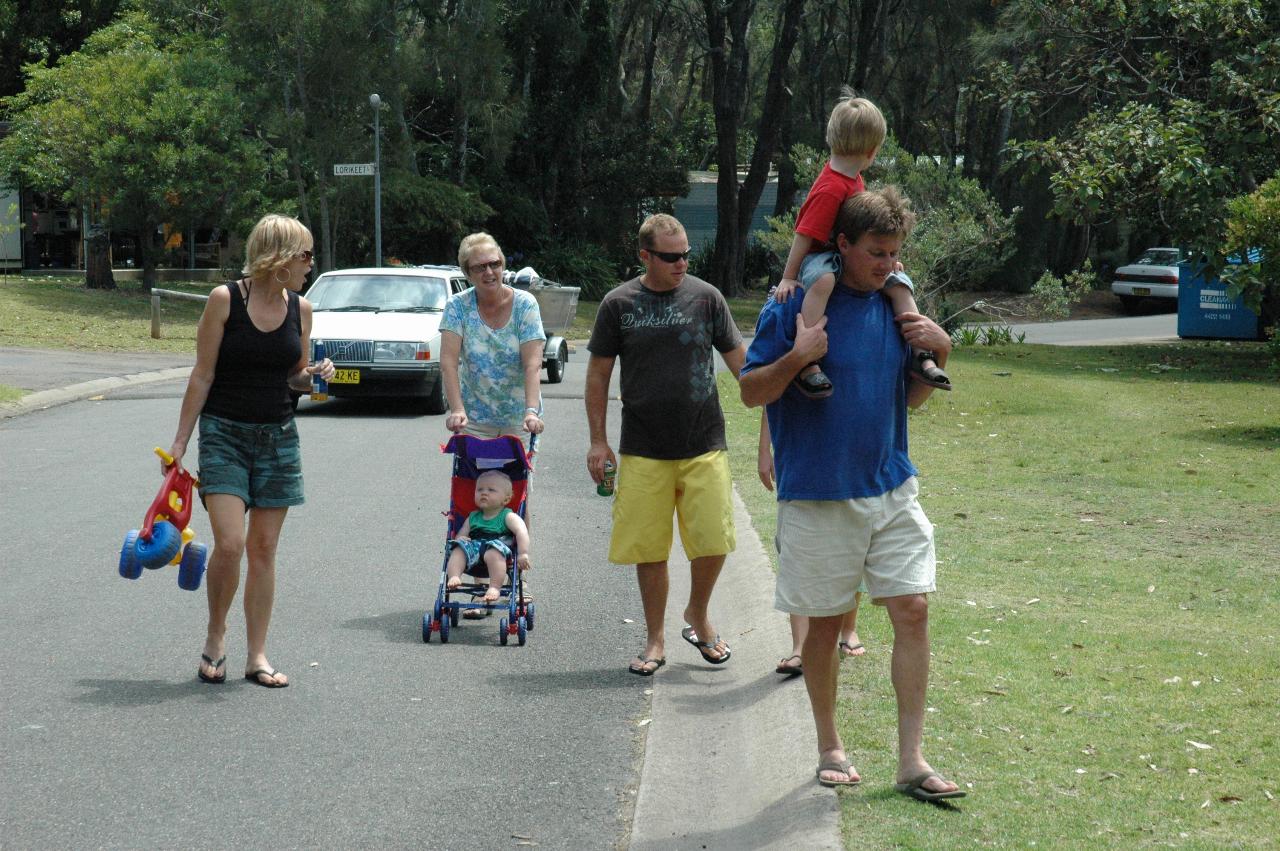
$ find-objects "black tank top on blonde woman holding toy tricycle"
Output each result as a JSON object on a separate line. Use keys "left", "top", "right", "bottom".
{"left": 204, "top": 282, "right": 302, "bottom": 422}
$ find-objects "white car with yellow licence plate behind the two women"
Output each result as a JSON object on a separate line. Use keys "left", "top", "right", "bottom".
{"left": 306, "top": 266, "right": 471, "bottom": 413}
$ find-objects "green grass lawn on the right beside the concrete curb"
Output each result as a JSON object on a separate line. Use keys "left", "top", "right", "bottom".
{"left": 722, "top": 343, "right": 1280, "bottom": 848}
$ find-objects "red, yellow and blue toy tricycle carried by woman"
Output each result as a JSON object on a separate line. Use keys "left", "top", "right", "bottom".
{"left": 120, "top": 447, "right": 209, "bottom": 591}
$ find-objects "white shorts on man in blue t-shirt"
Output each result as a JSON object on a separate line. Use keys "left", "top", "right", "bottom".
{"left": 773, "top": 476, "right": 937, "bottom": 618}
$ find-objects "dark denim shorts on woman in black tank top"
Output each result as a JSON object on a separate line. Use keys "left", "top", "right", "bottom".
{"left": 200, "top": 413, "right": 303, "bottom": 508}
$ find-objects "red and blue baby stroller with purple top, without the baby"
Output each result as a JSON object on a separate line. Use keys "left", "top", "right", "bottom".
{"left": 422, "top": 434, "right": 534, "bottom": 646}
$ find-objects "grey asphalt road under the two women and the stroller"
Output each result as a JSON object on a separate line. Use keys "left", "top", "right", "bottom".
{"left": 0, "top": 381, "right": 649, "bottom": 848}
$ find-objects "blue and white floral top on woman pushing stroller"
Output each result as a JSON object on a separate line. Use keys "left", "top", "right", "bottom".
{"left": 440, "top": 288, "right": 547, "bottom": 429}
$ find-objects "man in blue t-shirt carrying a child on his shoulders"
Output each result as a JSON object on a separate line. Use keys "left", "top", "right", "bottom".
{"left": 741, "top": 187, "right": 964, "bottom": 801}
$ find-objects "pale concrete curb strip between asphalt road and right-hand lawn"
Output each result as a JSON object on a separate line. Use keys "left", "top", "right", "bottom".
{"left": 630, "top": 493, "right": 842, "bottom": 851}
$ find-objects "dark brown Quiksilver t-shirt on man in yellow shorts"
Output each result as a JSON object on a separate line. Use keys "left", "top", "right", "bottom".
{"left": 588, "top": 275, "right": 742, "bottom": 459}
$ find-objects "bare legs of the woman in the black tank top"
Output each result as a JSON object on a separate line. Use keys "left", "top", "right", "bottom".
{"left": 201, "top": 494, "right": 288, "bottom": 685}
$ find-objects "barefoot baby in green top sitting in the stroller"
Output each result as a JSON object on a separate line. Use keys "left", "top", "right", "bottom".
{"left": 445, "top": 470, "right": 530, "bottom": 603}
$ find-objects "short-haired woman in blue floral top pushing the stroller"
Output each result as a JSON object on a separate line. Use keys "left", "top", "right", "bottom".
{"left": 440, "top": 233, "right": 547, "bottom": 438}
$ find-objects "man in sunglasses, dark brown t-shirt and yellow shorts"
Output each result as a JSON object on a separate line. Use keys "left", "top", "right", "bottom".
{"left": 585, "top": 214, "right": 746, "bottom": 677}
